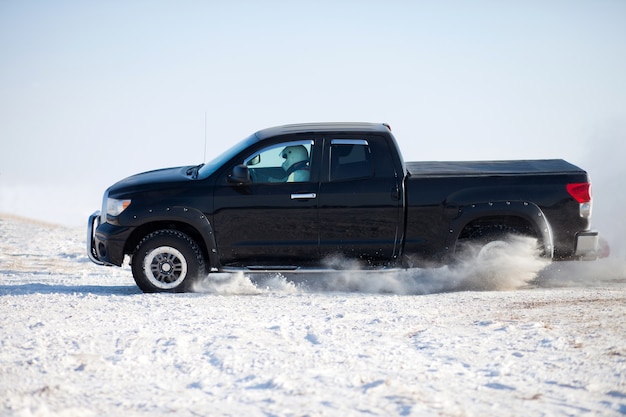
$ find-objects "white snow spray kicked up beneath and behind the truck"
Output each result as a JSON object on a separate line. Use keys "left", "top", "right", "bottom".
{"left": 194, "top": 236, "right": 549, "bottom": 295}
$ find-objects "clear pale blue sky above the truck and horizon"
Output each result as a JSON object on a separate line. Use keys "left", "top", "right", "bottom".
{"left": 0, "top": 0, "right": 626, "bottom": 228}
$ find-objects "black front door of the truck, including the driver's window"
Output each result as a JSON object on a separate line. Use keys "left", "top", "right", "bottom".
{"left": 213, "top": 137, "right": 319, "bottom": 267}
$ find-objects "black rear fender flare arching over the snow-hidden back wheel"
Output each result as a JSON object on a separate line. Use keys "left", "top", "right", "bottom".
{"left": 446, "top": 200, "right": 554, "bottom": 259}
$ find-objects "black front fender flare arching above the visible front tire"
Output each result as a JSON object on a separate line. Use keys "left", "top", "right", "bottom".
{"left": 123, "top": 206, "right": 219, "bottom": 269}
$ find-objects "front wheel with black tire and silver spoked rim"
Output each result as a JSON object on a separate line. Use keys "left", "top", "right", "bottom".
{"left": 131, "top": 229, "right": 206, "bottom": 293}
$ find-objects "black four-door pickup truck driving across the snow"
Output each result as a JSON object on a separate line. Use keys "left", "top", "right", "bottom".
{"left": 87, "top": 123, "right": 598, "bottom": 292}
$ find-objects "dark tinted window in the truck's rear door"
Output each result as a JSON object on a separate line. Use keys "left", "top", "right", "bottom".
{"left": 330, "top": 139, "right": 373, "bottom": 181}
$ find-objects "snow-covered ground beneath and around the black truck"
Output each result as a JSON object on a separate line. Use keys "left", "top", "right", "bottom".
{"left": 0, "top": 215, "right": 626, "bottom": 417}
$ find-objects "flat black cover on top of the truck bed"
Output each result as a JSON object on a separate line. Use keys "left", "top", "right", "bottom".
{"left": 406, "top": 159, "right": 585, "bottom": 177}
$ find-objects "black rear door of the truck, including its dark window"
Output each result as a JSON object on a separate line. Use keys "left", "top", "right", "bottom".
{"left": 318, "top": 135, "right": 402, "bottom": 263}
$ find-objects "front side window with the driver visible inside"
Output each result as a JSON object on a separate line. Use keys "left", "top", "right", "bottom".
{"left": 243, "top": 140, "right": 313, "bottom": 184}
